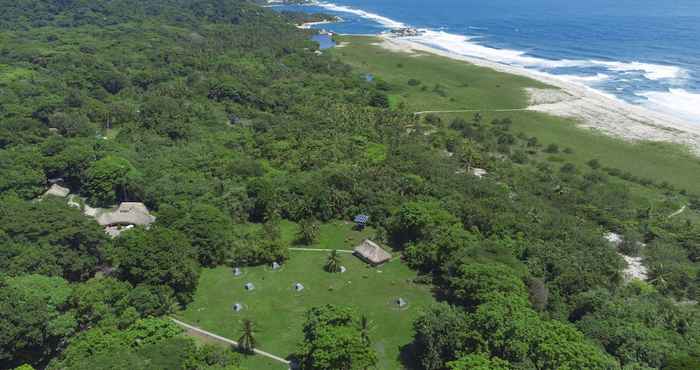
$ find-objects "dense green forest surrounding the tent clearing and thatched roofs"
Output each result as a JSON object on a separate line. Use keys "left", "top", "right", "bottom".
{"left": 0, "top": 0, "right": 700, "bottom": 370}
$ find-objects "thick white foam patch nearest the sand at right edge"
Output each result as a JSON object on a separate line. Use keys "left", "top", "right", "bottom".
{"left": 637, "top": 89, "right": 700, "bottom": 124}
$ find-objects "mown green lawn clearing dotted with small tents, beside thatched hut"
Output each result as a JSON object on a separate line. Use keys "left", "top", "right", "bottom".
{"left": 178, "top": 252, "right": 434, "bottom": 370}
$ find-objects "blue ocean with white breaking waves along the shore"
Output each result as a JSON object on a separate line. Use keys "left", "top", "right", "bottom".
{"left": 274, "top": 0, "right": 700, "bottom": 124}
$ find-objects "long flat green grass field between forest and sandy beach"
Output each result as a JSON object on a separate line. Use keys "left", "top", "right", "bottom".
{"left": 329, "top": 36, "right": 700, "bottom": 192}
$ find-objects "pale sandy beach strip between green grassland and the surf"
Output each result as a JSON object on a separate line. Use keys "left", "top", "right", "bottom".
{"left": 378, "top": 35, "right": 700, "bottom": 156}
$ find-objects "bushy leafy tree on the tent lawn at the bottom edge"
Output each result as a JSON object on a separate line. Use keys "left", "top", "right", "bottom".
{"left": 297, "top": 305, "right": 377, "bottom": 370}
